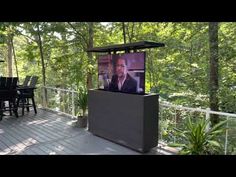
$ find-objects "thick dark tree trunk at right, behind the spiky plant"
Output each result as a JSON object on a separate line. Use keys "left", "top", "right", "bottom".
{"left": 209, "top": 22, "right": 219, "bottom": 125}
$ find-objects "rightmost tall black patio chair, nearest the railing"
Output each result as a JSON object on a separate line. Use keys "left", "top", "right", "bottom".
{"left": 17, "top": 76, "right": 38, "bottom": 115}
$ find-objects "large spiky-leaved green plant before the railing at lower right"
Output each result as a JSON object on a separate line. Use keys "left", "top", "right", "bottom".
{"left": 170, "top": 118, "right": 227, "bottom": 155}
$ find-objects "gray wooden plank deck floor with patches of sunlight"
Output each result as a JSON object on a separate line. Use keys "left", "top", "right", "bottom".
{"left": 0, "top": 109, "right": 175, "bottom": 155}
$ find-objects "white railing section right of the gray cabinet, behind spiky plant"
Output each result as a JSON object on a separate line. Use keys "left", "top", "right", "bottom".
{"left": 159, "top": 102, "right": 236, "bottom": 155}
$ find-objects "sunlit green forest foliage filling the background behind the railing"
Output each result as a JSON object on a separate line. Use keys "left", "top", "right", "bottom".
{"left": 0, "top": 22, "right": 236, "bottom": 113}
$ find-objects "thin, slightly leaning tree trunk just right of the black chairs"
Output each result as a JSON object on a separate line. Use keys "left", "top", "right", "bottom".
{"left": 37, "top": 23, "right": 47, "bottom": 107}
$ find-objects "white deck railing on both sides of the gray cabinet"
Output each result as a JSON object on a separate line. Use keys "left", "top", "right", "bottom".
{"left": 37, "top": 86, "right": 236, "bottom": 154}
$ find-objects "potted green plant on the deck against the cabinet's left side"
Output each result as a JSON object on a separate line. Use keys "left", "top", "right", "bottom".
{"left": 77, "top": 89, "right": 88, "bottom": 128}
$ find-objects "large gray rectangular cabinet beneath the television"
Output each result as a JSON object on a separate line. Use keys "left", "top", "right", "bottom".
{"left": 88, "top": 90, "right": 159, "bottom": 152}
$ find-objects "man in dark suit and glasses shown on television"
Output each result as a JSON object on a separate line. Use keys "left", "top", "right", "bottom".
{"left": 109, "top": 57, "right": 137, "bottom": 93}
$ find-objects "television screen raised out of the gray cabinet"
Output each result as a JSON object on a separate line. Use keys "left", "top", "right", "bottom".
{"left": 98, "top": 52, "right": 146, "bottom": 94}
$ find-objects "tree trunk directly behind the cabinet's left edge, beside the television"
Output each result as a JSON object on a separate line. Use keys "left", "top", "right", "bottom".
{"left": 87, "top": 22, "right": 94, "bottom": 89}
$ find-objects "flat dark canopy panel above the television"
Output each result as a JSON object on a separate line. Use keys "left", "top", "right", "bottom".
{"left": 87, "top": 41, "right": 165, "bottom": 53}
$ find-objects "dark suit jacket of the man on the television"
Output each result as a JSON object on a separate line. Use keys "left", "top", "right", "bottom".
{"left": 109, "top": 74, "right": 137, "bottom": 93}
